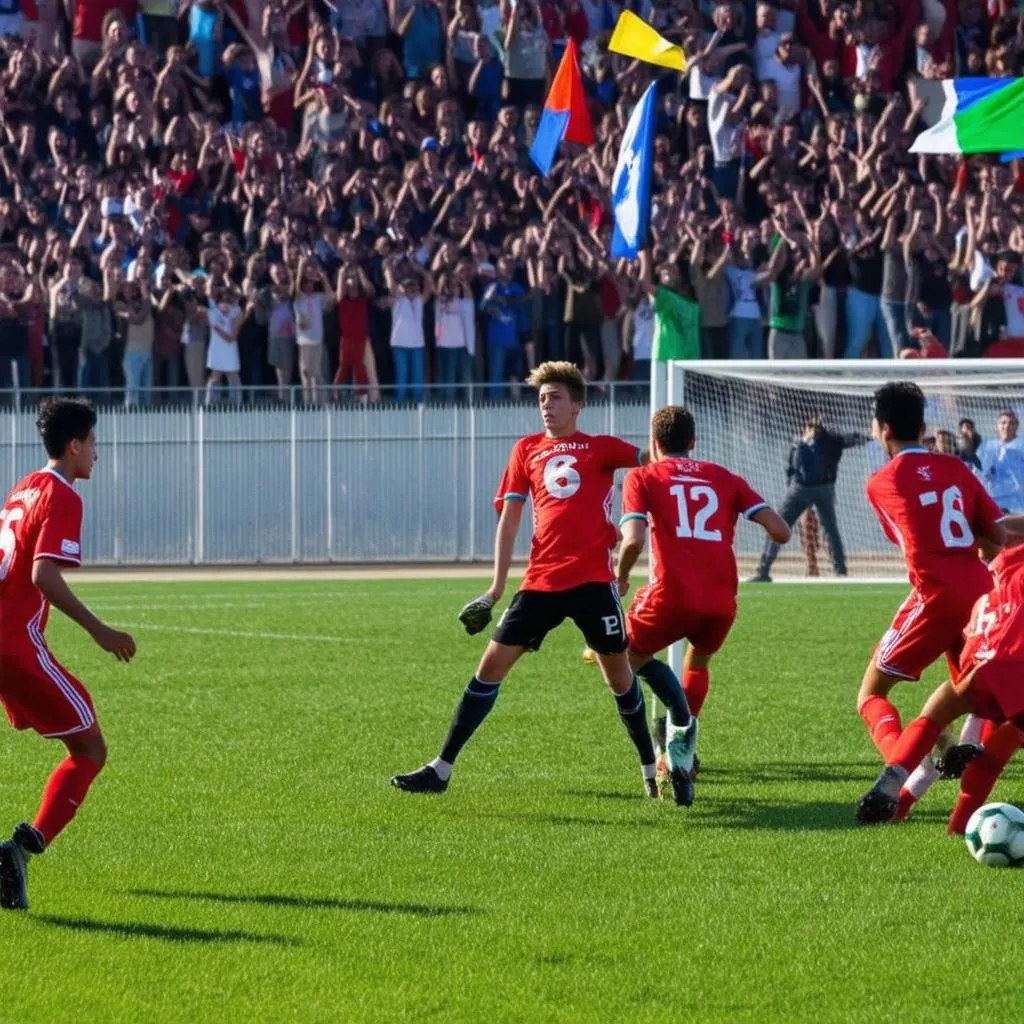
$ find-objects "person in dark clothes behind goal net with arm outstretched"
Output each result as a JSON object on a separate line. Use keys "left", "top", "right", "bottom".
{"left": 750, "top": 417, "right": 870, "bottom": 583}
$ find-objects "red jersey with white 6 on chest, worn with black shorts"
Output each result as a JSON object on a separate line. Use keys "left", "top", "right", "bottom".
{"left": 495, "top": 432, "right": 640, "bottom": 591}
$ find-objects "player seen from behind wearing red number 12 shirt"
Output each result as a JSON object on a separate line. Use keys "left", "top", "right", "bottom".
{"left": 617, "top": 406, "right": 791, "bottom": 805}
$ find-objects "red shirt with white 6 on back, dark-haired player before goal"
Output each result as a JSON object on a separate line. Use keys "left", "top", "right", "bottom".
{"left": 867, "top": 447, "right": 1002, "bottom": 602}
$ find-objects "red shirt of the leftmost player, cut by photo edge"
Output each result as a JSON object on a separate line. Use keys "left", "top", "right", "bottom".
{"left": 0, "top": 469, "right": 82, "bottom": 649}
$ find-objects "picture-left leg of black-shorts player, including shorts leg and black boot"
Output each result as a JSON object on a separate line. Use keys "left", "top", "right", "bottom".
{"left": 391, "top": 590, "right": 565, "bottom": 793}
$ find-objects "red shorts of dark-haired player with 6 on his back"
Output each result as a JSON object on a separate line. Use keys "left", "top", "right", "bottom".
{"left": 874, "top": 590, "right": 973, "bottom": 682}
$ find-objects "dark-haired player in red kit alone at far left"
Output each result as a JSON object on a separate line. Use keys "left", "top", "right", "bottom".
{"left": 0, "top": 398, "right": 135, "bottom": 910}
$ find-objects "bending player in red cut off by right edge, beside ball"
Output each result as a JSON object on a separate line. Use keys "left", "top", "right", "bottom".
{"left": 857, "top": 537, "right": 1024, "bottom": 835}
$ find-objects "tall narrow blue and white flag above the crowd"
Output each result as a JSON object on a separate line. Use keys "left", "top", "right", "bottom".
{"left": 611, "top": 82, "right": 657, "bottom": 259}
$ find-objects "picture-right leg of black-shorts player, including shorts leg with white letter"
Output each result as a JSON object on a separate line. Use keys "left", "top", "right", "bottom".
{"left": 563, "top": 583, "right": 657, "bottom": 797}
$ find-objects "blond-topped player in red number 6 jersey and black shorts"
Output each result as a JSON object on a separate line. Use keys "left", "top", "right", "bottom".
{"left": 391, "top": 362, "right": 657, "bottom": 797}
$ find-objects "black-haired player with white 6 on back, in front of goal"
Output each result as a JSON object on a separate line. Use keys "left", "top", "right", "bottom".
{"left": 857, "top": 381, "right": 1005, "bottom": 760}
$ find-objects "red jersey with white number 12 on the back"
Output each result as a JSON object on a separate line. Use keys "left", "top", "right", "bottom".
{"left": 623, "top": 458, "right": 768, "bottom": 608}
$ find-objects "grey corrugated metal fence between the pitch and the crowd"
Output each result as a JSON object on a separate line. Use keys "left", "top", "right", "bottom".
{"left": 6, "top": 388, "right": 648, "bottom": 564}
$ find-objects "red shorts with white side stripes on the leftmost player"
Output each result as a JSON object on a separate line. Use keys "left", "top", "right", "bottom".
{"left": 0, "top": 643, "right": 96, "bottom": 736}
